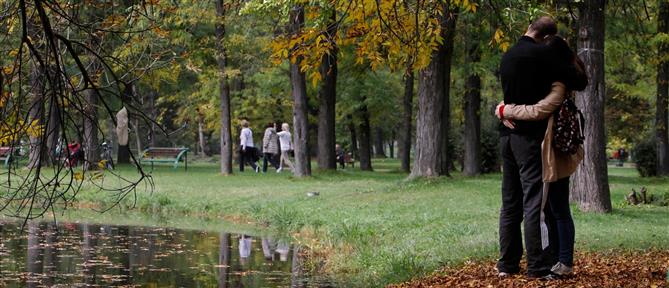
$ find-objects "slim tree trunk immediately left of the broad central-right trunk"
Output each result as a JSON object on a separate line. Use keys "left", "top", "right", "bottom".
{"left": 399, "top": 70, "right": 414, "bottom": 172}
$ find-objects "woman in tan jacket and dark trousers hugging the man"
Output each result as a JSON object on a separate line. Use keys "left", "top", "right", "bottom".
{"left": 495, "top": 36, "right": 587, "bottom": 276}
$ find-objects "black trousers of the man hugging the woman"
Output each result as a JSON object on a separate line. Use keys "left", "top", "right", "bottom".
{"left": 497, "top": 134, "right": 557, "bottom": 276}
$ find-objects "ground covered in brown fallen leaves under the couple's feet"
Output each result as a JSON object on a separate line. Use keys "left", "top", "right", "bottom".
{"left": 392, "top": 251, "right": 669, "bottom": 288}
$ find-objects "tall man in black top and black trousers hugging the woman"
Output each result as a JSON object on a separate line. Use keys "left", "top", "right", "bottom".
{"left": 497, "top": 17, "right": 565, "bottom": 277}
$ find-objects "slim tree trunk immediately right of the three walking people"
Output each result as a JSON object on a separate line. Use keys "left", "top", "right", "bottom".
{"left": 290, "top": 6, "right": 311, "bottom": 177}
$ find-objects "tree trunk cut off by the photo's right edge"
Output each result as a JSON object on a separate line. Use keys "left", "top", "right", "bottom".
{"left": 655, "top": 1, "right": 669, "bottom": 176}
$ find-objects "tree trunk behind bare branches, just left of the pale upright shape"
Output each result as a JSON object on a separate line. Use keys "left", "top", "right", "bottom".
{"left": 83, "top": 89, "right": 100, "bottom": 170}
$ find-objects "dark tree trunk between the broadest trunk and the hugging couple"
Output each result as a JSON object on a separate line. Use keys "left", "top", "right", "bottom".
{"left": 462, "top": 24, "right": 481, "bottom": 176}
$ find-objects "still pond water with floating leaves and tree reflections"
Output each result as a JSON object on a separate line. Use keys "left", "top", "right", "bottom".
{"left": 0, "top": 222, "right": 314, "bottom": 287}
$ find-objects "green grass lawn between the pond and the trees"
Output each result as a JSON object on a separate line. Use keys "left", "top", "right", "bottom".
{"left": 62, "top": 160, "right": 669, "bottom": 287}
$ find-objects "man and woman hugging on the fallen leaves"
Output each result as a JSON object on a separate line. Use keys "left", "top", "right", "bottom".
{"left": 495, "top": 17, "right": 588, "bottom": 279}
